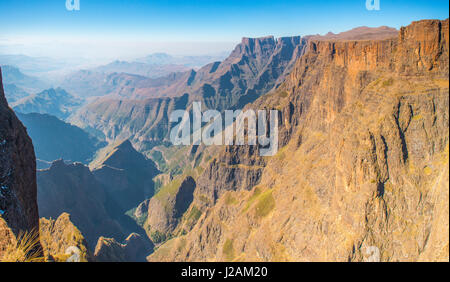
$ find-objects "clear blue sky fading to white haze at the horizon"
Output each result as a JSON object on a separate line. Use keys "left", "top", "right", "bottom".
{"left": 0, "top": 0, "right": 449, "bottom": 58}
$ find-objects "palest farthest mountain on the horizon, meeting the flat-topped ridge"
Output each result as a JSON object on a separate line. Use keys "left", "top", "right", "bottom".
{"left": 137, "top": 53, "right": 228, "bottom": 68}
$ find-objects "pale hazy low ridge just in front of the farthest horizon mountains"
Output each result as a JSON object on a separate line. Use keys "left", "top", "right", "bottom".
{"left": 93, "top": 61, "right": 189, "bottom": 78}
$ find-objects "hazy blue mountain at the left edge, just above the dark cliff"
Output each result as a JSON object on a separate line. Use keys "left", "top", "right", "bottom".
{"left": 0, "top": 64, "right": 49, "bottom": 92}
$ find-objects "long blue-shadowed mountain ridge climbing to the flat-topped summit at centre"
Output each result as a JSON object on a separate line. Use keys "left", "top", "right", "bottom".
{"left": 70, "top": 37, "right": 306, "bottom": 150}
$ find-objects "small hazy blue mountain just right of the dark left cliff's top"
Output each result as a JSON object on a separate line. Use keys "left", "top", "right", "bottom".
{"left": 12, "top": 88, "right": 83, "bottom": 120}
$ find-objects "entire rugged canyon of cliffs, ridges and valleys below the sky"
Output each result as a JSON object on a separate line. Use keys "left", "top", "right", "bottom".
{"left": 0, "top": 19, "right": 449, "bottom": 262}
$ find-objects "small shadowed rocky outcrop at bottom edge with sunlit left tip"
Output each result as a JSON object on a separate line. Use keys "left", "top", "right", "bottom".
{"left": 94, "top": 233, "right": 153, "bottom": 262}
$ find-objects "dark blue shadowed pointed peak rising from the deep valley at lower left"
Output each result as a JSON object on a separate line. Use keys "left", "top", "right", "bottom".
{"left": 37, "top": 141, "right": 158, "bottom": 251}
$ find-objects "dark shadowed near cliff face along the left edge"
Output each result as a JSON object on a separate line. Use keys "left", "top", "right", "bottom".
{"left": 0, "top": 67, "right": 39, "bottom": 257}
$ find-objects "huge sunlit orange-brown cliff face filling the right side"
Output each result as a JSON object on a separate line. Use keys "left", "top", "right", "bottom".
{"left": 148, "top": 19, "right": 449, "bottom": 261}
